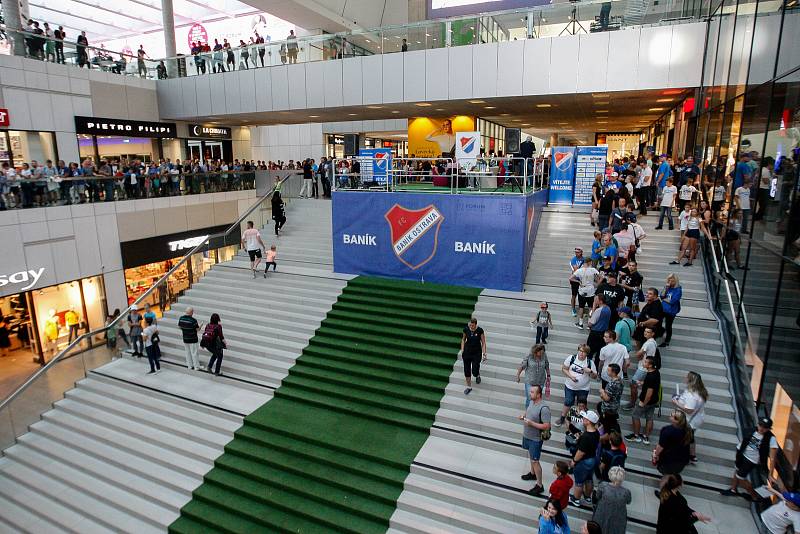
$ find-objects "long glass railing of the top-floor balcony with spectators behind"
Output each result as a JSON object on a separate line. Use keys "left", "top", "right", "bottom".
{"left": 0, "top": 0, "right": 710, "bottom": 79}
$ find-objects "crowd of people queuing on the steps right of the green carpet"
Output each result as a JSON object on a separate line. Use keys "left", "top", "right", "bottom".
{"left": 461, "top": 152, "right": 800, "bottom": 534}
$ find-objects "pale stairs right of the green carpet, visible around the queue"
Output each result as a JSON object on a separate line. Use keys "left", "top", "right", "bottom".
{"left": 393, "top": 209, "right": 753, "bottom": 532}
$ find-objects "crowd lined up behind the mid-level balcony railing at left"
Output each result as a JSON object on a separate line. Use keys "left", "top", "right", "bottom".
{"left": 0, "top": 158, "right": 269, "bottom": 210}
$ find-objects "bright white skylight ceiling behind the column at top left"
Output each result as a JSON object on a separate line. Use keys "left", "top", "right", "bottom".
{"left": 23, "top": 0, "right": 260, "bottom": 43}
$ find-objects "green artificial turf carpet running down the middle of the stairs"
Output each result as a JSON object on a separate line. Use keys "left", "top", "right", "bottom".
{"left": 169, "top": 277, "right": 480, "bottom": 534}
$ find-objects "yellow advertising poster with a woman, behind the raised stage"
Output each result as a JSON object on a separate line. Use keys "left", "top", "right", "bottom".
{"left": 408, "top": 115, "right": 475, "bottom": 158}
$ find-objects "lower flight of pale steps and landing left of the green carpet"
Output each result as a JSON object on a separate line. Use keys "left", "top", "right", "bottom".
{"left": 0, "top": 359, "right": 271, "bottom": 534}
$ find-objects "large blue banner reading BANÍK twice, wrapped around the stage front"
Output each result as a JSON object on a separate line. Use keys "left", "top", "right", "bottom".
{"left": 333, "top": 191, "right": 546, "bottom": 291}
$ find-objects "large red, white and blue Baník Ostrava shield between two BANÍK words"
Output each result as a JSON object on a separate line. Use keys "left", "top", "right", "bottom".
{"left": 384, "top": 204, "right": 444, "bottom": 270}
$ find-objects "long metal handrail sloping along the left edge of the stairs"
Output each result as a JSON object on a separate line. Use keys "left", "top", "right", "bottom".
{"left": 0, "top": 175, "right": 296, "bottom": 412}
